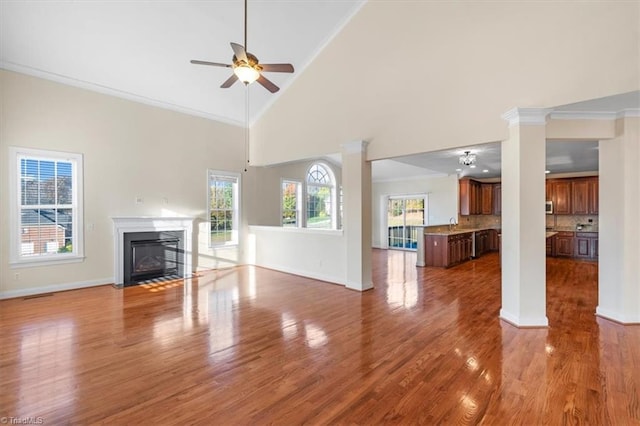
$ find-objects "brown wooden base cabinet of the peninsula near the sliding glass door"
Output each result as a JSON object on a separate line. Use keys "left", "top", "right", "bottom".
{"left": 424, "top": 232, "right": 473, "bottom": 268}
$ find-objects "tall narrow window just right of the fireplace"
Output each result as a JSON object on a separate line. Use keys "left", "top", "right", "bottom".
{"left": 208, "top": 170, "right": 240, "bottom": 247}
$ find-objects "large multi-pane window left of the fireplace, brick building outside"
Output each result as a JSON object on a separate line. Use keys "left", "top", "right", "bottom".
{"left": 9, "top": 147, "right": 84, "bottom": 266}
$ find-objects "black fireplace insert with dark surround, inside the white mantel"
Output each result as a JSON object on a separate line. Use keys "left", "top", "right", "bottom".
{"left": 123, "top": 231, "right": 184, "bottom": 286}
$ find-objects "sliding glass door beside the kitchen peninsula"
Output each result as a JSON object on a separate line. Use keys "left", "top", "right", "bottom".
{"left": 387, "top": 196, "right": 426, "bottom": 250}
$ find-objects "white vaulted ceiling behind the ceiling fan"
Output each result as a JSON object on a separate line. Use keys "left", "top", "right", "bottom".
{"left": 0, "top": 0, "right": 364, "bottom": 125}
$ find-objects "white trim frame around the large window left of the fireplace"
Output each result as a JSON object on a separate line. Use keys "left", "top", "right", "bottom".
{"left": 8, "top": 146, "right": 84, "bottom": 268}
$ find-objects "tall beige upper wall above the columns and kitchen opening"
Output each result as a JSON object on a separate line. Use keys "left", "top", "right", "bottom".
{"left": 251, "top": 0, "right": 640, "bottom": 164}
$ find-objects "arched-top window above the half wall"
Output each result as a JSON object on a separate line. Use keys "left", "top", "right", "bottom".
{"left": 306, "top": 163, "right": 336, "bottom": 229}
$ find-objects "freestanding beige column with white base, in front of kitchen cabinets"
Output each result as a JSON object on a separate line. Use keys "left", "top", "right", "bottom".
{"left": 500, "top": 108, "right": 549, "bottom": 327}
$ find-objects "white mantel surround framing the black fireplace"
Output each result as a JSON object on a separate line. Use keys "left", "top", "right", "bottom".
{"left": 111, "top": 216, "right": 194, "bottom": 285}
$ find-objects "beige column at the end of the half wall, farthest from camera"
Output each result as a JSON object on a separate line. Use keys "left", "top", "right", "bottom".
{"left": 342, "top": 141, "right": 373, "bottom": 291}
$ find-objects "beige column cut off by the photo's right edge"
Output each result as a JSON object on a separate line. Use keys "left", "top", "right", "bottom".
{"left": 596, "top": 116, "right": 640, "bottom": 324}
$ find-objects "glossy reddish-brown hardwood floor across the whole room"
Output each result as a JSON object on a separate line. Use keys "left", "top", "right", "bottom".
{"left": 0, "top": 250, "right": 640, "bottom": 425}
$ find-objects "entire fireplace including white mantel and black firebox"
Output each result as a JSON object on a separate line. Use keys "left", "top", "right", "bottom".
{"left": 113, "top": 217, "right": 193, "bottom": 287}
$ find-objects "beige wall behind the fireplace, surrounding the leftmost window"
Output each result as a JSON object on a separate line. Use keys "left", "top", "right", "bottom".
{"left": 0, "top": 71, "right": 248, "bottom": 295}
